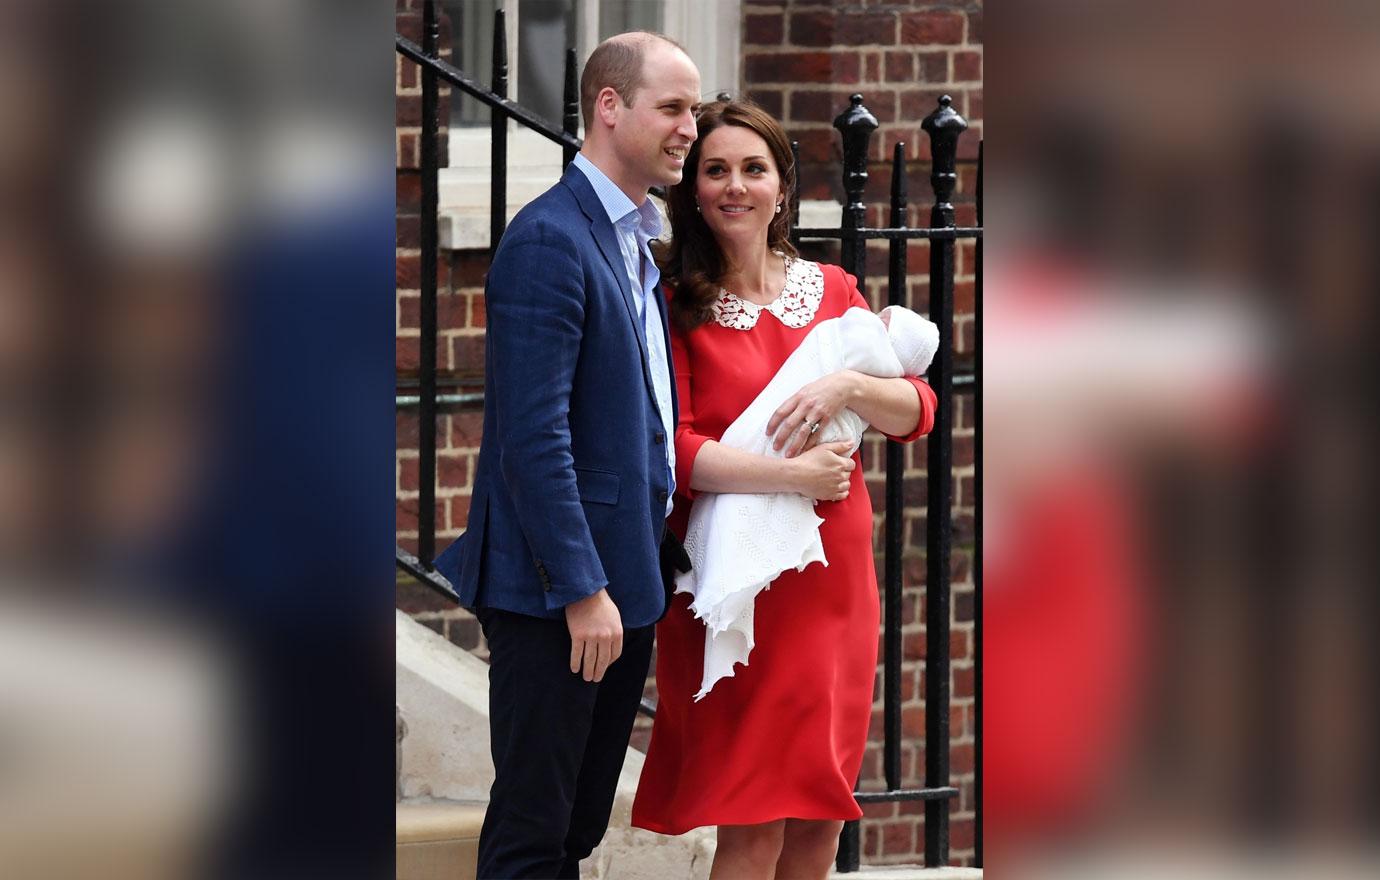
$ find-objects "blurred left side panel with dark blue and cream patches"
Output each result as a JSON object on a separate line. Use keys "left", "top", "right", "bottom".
{"left": 0, "top": 0, "right": 395, "bottom": 880}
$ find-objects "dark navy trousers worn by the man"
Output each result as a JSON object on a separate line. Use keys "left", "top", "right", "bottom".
{"left": 477, "top": 608, "right": 654, "bottom": 880}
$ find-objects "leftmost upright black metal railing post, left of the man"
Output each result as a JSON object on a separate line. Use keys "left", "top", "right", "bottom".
{"left": 417, "top": 0, "right": 440, "bottom": 571}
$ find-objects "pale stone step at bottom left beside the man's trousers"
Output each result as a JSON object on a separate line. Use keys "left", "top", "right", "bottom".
{"left": 395, "top": 800, "right": 484, "bottom": 880}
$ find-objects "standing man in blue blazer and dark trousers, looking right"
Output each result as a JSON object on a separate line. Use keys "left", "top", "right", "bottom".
{"left": 436, "top": 32, "right": 700, "bottom": 879}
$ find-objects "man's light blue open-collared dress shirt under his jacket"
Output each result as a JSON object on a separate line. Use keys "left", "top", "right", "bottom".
{"left": 573, "top": 153, "right": 676, "bottom": 516}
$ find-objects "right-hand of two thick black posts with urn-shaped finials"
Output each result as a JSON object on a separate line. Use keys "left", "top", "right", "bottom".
{"left": 920, "top": 95, "right": 967, "bottom": 868}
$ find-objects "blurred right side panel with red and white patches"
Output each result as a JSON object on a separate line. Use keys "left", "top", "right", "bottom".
{"left": 983, "top": 1, "right": 1380, "bottom": 879}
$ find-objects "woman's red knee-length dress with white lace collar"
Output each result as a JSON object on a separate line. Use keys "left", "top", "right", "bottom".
{"left": 632, "top": 261, "right": 936, "bottom": 834}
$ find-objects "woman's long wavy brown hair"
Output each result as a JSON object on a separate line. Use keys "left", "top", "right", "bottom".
{"left": 656, "top": 101, "right": 796, "bottom": 331}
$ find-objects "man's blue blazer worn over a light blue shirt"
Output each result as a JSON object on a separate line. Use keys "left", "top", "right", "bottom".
{"left": 436, "top": 166, "right": 676, "bottom": 628}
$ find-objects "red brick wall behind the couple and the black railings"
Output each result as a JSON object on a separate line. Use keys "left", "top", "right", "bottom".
{"left": 397, "top": 0, "right": 983, "bottom": 863}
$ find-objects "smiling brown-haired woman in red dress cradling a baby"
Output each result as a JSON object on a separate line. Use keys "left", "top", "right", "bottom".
{"left": 632, "top": 102, "right": 936, "bottom": 880}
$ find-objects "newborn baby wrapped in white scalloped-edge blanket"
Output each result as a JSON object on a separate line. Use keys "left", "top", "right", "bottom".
{"left": 676, "top": 306, "right": 938, "bottom": 701}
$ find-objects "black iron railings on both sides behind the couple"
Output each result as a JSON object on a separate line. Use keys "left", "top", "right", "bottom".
{"left": 396, "top": 0, "right": 983, "bottom": 872}
